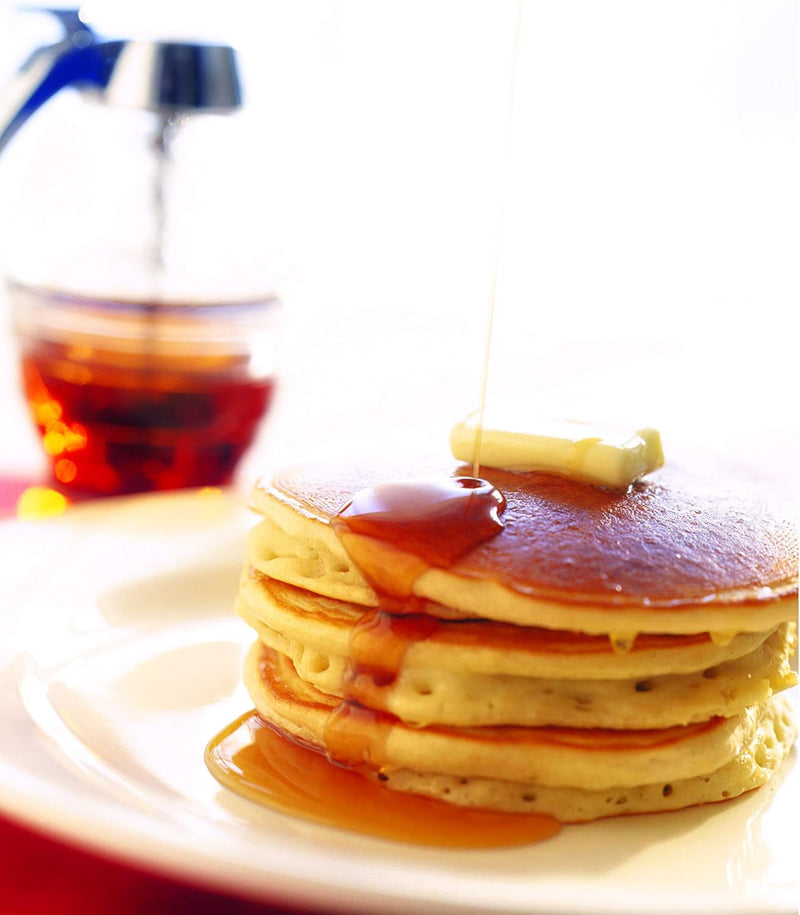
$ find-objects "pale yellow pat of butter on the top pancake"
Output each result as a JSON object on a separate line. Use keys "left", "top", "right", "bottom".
{"left": 450, "top": 409, "right": 664, "bottom": 490}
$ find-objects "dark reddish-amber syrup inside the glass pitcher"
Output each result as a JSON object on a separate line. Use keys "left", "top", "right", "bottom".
{"left": 22, "top": 343, "right": 273, "bottom": 495}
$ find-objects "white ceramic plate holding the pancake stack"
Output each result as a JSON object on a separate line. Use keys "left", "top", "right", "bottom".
{"left": 0, "top": 493, "right": 798, "bottom": 915}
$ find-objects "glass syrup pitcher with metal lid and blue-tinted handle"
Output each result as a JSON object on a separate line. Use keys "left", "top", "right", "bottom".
{"left": 0, "top": 10, "right": 279, "bottom": 495}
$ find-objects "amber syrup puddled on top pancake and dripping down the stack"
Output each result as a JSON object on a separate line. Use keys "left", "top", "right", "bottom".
{"left": 325, "top": 477, "right": 505, "bottom": 766}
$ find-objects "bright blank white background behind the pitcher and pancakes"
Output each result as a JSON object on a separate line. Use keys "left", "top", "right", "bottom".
{"left": 0, "top": 0, "right": 800, "bottom": 486}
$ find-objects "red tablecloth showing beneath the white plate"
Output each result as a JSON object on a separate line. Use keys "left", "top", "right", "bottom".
{"left": 0, "top": 477, "right": 316, "bottom": 915}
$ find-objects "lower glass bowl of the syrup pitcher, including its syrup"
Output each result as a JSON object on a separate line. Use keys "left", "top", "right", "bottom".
{"left": 10, "top": 284, "right": 274, "bottom": 495}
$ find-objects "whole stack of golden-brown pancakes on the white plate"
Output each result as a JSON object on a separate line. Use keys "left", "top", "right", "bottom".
{"left": 237, "top": 460, "right": 797, "bottom": 822}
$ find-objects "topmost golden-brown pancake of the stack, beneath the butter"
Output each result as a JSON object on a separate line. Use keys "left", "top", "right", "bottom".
{"left": 249, "top": 462, "right": 797, "bottom": 637}
